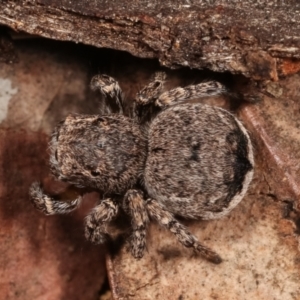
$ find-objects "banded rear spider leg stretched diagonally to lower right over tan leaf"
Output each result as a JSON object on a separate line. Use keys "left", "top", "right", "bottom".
{"left": 146, "top": 199, "right": 222, "bottom": 264}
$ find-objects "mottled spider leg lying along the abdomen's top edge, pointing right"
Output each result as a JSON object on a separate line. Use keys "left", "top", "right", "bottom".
{"left": 155, "top": 81, "right": 227, "bottom": 107}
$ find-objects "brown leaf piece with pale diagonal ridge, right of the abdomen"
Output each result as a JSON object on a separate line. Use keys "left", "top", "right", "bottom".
{"left": 239, "top": 74, "right": 300, "bottom": 206}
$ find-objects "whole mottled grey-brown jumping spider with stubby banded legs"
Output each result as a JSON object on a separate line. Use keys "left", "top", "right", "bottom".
{"left": 30, "top": 72, "right": 254, "bottom": 263}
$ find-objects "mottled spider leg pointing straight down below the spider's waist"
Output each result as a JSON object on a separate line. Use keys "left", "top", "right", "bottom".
{"left": 123, "top": 190, "right": 149, "bottom": 258}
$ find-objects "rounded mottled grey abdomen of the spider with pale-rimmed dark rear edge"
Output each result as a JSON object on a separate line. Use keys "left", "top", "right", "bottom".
{"left": 144, "top": 103, "right": 254, "bottom": 219}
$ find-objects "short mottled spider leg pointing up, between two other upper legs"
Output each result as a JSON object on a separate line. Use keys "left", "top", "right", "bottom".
{"left": 134, "top": 72, "right": 166, "bottom": 120}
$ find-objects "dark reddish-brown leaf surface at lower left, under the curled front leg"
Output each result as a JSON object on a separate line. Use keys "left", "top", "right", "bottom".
{"left": 0, "top": 129, "right": 105, "bottom": 300}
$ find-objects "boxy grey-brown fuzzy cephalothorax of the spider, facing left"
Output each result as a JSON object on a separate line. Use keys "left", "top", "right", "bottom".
{"left": 50, "top": 114, "right": 147, "bottom": 193}
